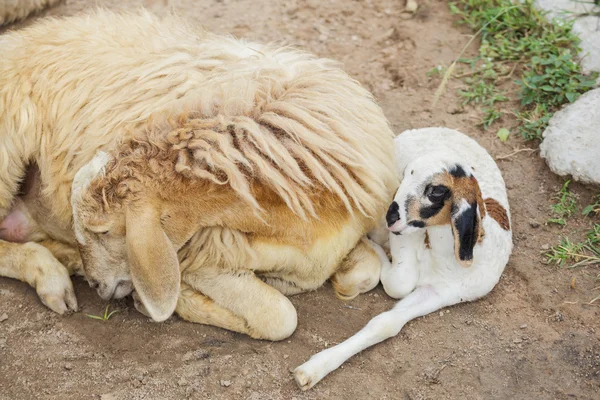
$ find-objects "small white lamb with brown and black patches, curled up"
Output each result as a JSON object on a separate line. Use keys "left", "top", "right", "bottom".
{"left": 294, "top": 128, "right": 513, "bottom": 390}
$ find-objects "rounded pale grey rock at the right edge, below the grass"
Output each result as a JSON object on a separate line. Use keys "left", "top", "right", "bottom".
{"left": 540, "top": 89, "right": 600, "bottom": 185}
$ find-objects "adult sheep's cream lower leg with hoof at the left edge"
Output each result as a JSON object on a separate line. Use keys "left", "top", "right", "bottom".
{"left": 0, "top": 240, "right": 77, "bottom": 314}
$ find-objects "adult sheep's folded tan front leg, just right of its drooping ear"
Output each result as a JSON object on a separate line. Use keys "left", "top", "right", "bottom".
{"left": 177, "top": 265, "right": 297, "bottom": 341}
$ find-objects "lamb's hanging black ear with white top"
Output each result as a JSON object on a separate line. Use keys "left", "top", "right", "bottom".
{"left": 451, "top": 199, "right": 481, "bottom": 268}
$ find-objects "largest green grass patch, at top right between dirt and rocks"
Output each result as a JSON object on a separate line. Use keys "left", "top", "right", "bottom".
{"left": 447, "top": 0, "right": 597, "bottom": 139}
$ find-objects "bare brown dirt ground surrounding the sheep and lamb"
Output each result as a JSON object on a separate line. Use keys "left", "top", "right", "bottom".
{"left": 0, "top": 0, "right": 600, "bottom": 400}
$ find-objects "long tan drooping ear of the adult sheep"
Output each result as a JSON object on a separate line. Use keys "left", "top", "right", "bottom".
{"left": 125, "top": 200, "right": 181, "bottom": 322}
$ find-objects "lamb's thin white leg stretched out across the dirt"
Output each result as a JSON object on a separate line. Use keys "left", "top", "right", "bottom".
{"left": 294, "top": 286, "right": 461, "bottom": 390}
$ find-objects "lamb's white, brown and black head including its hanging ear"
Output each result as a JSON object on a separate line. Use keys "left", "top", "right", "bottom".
{"left": 386, "top": 154, "right": 485, "bottom": 267}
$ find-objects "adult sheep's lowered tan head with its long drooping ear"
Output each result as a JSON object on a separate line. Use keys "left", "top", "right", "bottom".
{"left": 71, "top": 153, "right": 180, "bottom": 321}
